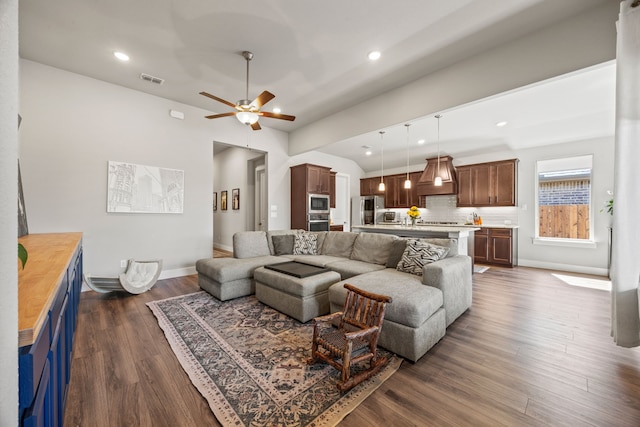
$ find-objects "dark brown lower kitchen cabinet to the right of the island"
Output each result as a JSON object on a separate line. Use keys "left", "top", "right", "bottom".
{"left": 474, "top": 228, "right": 514, "bottom": 267}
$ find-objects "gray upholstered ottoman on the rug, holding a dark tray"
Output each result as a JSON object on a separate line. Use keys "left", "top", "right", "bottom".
{"left": 253, "top": 267, "right": 340, "bottom": 323}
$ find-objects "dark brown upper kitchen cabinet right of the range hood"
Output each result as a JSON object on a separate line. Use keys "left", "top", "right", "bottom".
{"left": 456, "top": 159, "right": 518, "bottom": 207}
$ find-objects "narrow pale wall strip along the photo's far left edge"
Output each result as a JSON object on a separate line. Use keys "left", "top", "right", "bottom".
{"left": 0, "top": 0, "right": 18, "bottom": 426}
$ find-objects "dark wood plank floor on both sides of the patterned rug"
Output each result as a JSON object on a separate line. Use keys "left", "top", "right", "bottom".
{"left": 65, "top": 267, "right": 640, "bottom": 427}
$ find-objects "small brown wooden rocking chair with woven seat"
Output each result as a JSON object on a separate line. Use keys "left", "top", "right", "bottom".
{"left": 308, "top": 284, "right": 391, "bottom": 391}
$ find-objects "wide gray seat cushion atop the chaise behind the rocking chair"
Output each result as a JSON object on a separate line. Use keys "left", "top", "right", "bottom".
{"left": 329, "top": 268, "right": 443, "bottom": 328}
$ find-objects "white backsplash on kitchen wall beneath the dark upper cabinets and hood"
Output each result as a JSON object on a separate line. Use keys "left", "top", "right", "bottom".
{"left": 388, "top": 195, "right": 518, "bottom": 225}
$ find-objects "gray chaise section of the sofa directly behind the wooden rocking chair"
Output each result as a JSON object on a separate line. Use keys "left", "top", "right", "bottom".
{"left": 329, "top": 268, "right": 447, "bottom": 362}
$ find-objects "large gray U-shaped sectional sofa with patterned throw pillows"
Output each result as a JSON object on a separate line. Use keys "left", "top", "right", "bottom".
{"left": 196, "top": 230, "right": 472, "bottom": 362}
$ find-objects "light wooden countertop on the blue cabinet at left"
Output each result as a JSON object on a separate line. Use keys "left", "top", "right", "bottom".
{"left": 18, "top": 233, "right": 82, "bottom": 347}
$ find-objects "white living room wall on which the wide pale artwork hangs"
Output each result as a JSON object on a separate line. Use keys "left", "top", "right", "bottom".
{"left": 20, "top": 60, "right": 289, "bottom": 277}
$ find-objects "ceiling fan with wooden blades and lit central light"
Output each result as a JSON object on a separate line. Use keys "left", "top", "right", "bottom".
{"left": 200, "top": 50, "right": 296, "bottom": 130}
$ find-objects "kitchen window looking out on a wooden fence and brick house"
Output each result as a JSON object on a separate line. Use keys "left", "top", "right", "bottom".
{"left": 535, "top": 155, "right": 593, "bottom": 245}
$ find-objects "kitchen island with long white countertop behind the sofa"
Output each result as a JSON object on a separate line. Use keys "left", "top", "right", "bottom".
{"left": 351, "top": 224, "right": 480, "bottom": 259}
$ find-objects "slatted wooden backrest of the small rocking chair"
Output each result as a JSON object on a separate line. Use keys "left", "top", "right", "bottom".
{"left": 342, "top": 283, "right": 391, "bottom": 329}
